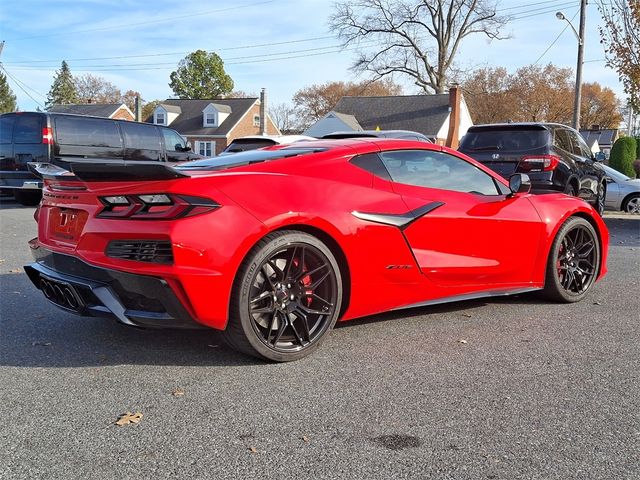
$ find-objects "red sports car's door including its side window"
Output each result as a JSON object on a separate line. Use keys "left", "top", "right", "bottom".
{"left": 380, "top": 150, "right": 543, "bottom": 290}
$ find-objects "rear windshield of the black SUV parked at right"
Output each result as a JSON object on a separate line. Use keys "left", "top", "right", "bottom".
{"left": 460, "top": 128, "right": 549, "bottom": 152}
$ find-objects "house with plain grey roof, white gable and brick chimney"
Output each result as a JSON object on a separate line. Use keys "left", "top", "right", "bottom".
{"left": 304, "top": 86, "right": 473, "bottom": 148}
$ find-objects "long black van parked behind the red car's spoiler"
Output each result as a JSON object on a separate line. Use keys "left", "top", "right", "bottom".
{"left": 0, "top": 112, "right": 203, "bottom": 205}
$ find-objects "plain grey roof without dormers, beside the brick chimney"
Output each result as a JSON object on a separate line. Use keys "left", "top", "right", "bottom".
{"left": 333, "top": 93, "right": 449, "bottom": 137}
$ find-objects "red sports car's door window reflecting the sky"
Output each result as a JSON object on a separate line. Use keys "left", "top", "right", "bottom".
{"left": 380, "top": 150, "right": 501, "bottom": 195}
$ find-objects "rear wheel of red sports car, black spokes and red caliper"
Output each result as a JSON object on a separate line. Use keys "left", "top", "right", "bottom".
{"left": 222, "top": 230, "right": 342, "bottom": 362}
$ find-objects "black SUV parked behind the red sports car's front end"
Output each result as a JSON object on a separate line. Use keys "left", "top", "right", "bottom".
{"left": 458, "top": 123, "right": 607, "bottom": 214}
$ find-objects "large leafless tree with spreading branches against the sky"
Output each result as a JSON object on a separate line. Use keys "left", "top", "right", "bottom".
{"left": 329, "top": 0, "right": 508, "bottom": 93}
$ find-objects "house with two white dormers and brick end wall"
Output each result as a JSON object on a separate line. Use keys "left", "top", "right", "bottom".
{"left": 151, "top": 89, "right": 280, "bottom": 157}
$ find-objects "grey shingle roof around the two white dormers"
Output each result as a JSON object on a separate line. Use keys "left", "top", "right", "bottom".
{"left": 145, "top": 97, "right": 258, "bottom": 136}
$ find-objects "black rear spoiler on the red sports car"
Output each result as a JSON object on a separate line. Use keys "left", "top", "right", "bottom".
{"left": 28, "top": 160, "right": 189, "bottom": 182}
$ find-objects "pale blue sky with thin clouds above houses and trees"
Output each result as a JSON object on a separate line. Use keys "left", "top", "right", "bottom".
{"left": 0, "top": 0, "right": 624, "bottom": 110}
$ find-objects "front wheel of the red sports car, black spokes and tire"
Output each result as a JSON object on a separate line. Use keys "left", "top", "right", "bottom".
{"left": 543, "top": 217, "right": 600, "bottom": 303}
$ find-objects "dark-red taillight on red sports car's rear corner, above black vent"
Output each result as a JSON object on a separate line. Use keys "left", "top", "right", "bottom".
{"left": 98, "top": 193, "right": 220, "bottom": 220}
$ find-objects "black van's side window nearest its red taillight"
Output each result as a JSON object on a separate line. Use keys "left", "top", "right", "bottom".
{"left": 55, "top": 116, "right": 122, "bottom": 148}
